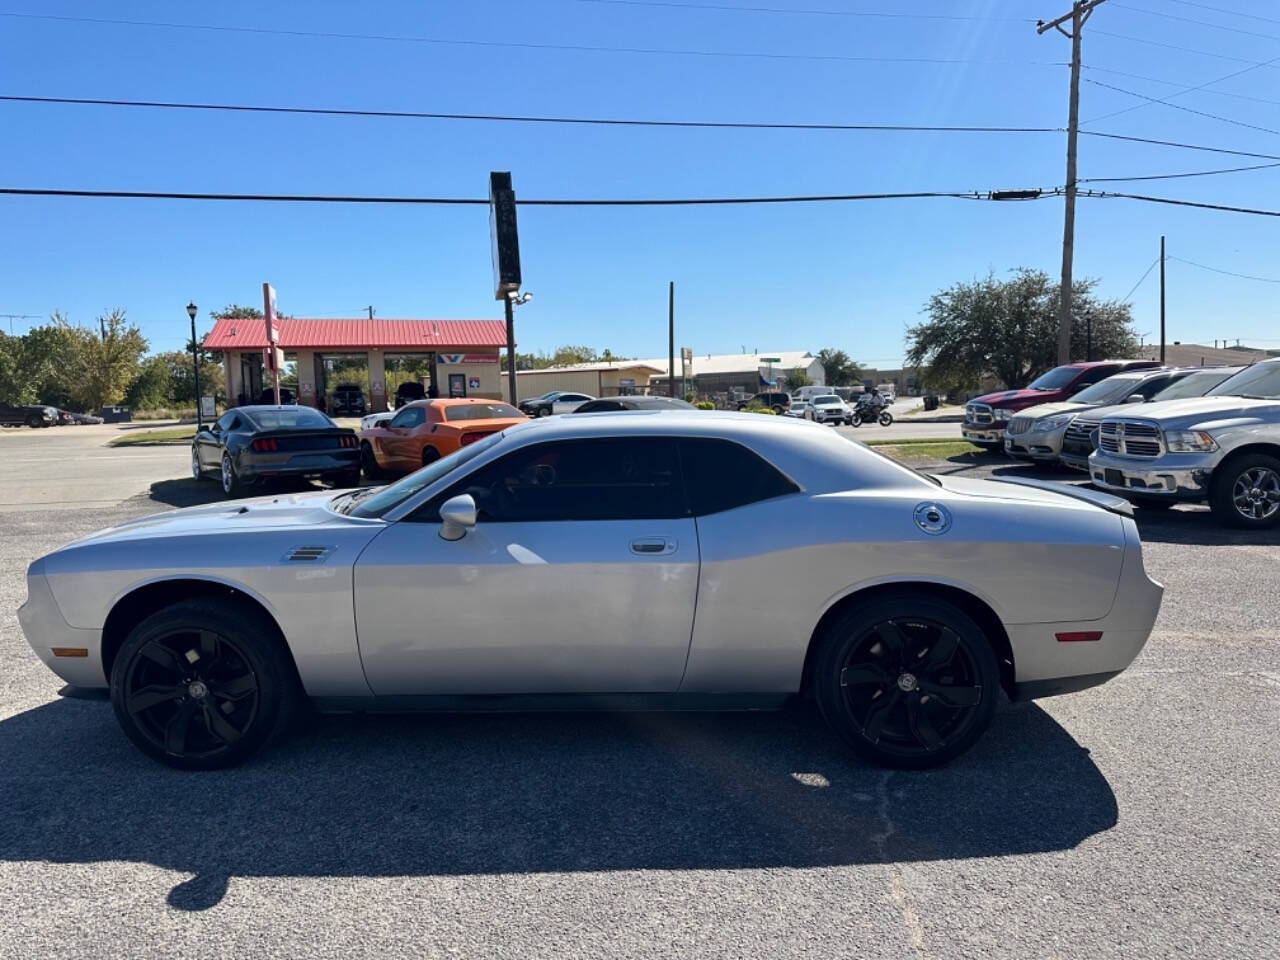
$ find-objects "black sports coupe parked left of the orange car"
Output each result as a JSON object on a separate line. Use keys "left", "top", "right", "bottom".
{"left": 191, "top": 406, "right": 360, "bottom": 497}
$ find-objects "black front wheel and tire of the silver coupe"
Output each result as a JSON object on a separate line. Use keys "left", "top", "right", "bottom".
{"left": 111, "top": 599, "right": 301, "bottom": 771}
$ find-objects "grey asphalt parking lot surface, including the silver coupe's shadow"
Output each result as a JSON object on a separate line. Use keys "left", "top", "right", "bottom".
{"left": 0, "top": 428, "right": 1280, "bottom": 957}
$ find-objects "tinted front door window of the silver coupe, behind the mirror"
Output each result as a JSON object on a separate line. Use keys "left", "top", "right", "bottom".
{"left": 413, "top": 436, "right": 689, "bottom": 524}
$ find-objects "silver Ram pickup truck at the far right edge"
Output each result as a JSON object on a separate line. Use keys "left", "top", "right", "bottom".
{"left": 1089, "top": 357, "right": 1280, "bottom": 527}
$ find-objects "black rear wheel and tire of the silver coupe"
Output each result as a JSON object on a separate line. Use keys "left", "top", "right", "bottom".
{"left": 810, "top": 594, "right": 1000, "bottom": 769}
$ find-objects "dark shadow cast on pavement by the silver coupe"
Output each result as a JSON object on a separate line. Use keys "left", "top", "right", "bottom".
{"left": 0, "top": 699, "right": 1117, "bottom": 910}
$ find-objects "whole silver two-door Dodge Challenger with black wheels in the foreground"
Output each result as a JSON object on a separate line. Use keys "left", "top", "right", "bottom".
{"left": 18, "top": 411, "right": 1164, "bottom": 768}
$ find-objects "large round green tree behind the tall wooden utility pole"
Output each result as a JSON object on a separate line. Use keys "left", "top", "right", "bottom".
{"left": 906, "top": 268, "right": 1138, "bottom": 390}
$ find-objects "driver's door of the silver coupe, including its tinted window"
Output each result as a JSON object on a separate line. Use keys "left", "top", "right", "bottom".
{"left": 355, "top": 436, "right": 699, "bottom": 695}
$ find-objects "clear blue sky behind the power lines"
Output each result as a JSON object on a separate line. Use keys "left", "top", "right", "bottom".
{"left": 0, "top": 0, "right": 1280, "bottom": 367}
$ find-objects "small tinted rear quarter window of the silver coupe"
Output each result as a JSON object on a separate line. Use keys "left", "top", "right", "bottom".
{"left": 678, "top": 438, "right": 800, "bottom": 517}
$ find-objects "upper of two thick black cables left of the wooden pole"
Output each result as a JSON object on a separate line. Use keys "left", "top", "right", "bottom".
{"left": 0, "top": 95, "right": 1061, "bottom": 133}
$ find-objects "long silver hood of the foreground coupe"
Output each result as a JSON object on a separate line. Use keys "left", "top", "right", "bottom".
{"left": 68, "top": 490, "right": 344, "bottom": 547}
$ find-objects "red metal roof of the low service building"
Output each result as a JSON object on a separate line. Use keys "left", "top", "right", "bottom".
{"left": 205, "top": 316, "right": 507, "bottom": 349}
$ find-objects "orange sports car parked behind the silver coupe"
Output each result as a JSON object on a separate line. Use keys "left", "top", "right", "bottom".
{"left": 360, "top": 398, "right": 529, "bottom": 477}
